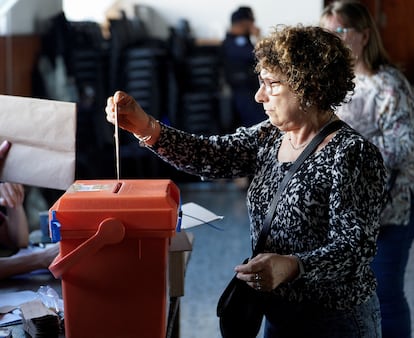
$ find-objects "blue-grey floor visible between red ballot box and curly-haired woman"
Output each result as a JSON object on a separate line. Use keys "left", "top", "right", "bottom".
{"left": 180, "top": 182, "right": 414, "bottom": 338}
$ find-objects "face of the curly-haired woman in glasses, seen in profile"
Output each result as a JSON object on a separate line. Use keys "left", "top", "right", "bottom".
{"left": 255, "top": 69, "right": 304, "bottom": 131}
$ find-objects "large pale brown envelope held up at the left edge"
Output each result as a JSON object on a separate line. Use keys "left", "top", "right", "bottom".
{"left": 0, "top": 95, "right": 76, "bottom": 190}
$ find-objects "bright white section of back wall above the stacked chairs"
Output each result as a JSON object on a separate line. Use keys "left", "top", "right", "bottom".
{"left": 63, "top": 0, "right": 323, "bottom": 39}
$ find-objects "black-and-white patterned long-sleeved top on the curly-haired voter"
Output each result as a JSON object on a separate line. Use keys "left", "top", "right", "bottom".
{"left": 152, "top": 121, "right": 386, "bottom": 308}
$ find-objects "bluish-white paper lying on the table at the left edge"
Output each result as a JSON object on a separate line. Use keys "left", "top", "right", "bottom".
{"left": 0, "top": 291, "right": 39, "bottom": 327}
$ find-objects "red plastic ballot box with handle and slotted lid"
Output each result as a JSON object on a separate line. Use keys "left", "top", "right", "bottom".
{"left": 49, "top": 180, "right": 180, "bottom": 338}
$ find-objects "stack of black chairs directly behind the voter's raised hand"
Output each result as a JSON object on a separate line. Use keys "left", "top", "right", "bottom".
{"left": 109, "top": 15, "right": 170, "bottom": 178}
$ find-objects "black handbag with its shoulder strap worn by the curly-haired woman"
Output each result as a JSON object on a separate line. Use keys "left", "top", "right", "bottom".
{"left": 217, "top": 120, "right": 344, "bottom": 338}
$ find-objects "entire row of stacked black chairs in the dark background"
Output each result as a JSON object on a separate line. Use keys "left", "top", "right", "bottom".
{"left": 36, "top": 11, "right": 221, "bottom": 180}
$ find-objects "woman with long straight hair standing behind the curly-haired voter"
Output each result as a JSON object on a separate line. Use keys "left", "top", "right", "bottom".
{"left": 321, "top": 0, "right": 414, "bottom": 338}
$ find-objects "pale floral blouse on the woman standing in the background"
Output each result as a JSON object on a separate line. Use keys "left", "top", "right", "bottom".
{"left": 337, "top": 66, "right": 414, "bottom": 225}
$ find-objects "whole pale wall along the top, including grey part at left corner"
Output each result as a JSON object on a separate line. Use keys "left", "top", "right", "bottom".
{"left": 0, "top": 0, "right": 323, "bottom": 39}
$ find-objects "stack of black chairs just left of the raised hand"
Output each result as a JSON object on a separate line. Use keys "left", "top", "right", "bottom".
{"left": 69, "top": 22, "right": 114, "bottom": 179}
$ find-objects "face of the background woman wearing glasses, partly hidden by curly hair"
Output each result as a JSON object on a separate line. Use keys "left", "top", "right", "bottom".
{"left": 321, "top": 14, "right": 369, "bottom": 60}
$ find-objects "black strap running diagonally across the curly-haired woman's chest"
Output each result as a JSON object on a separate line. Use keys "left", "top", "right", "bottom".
{"left": 253, "top": 120, "right": 345, "bottom": 256}
